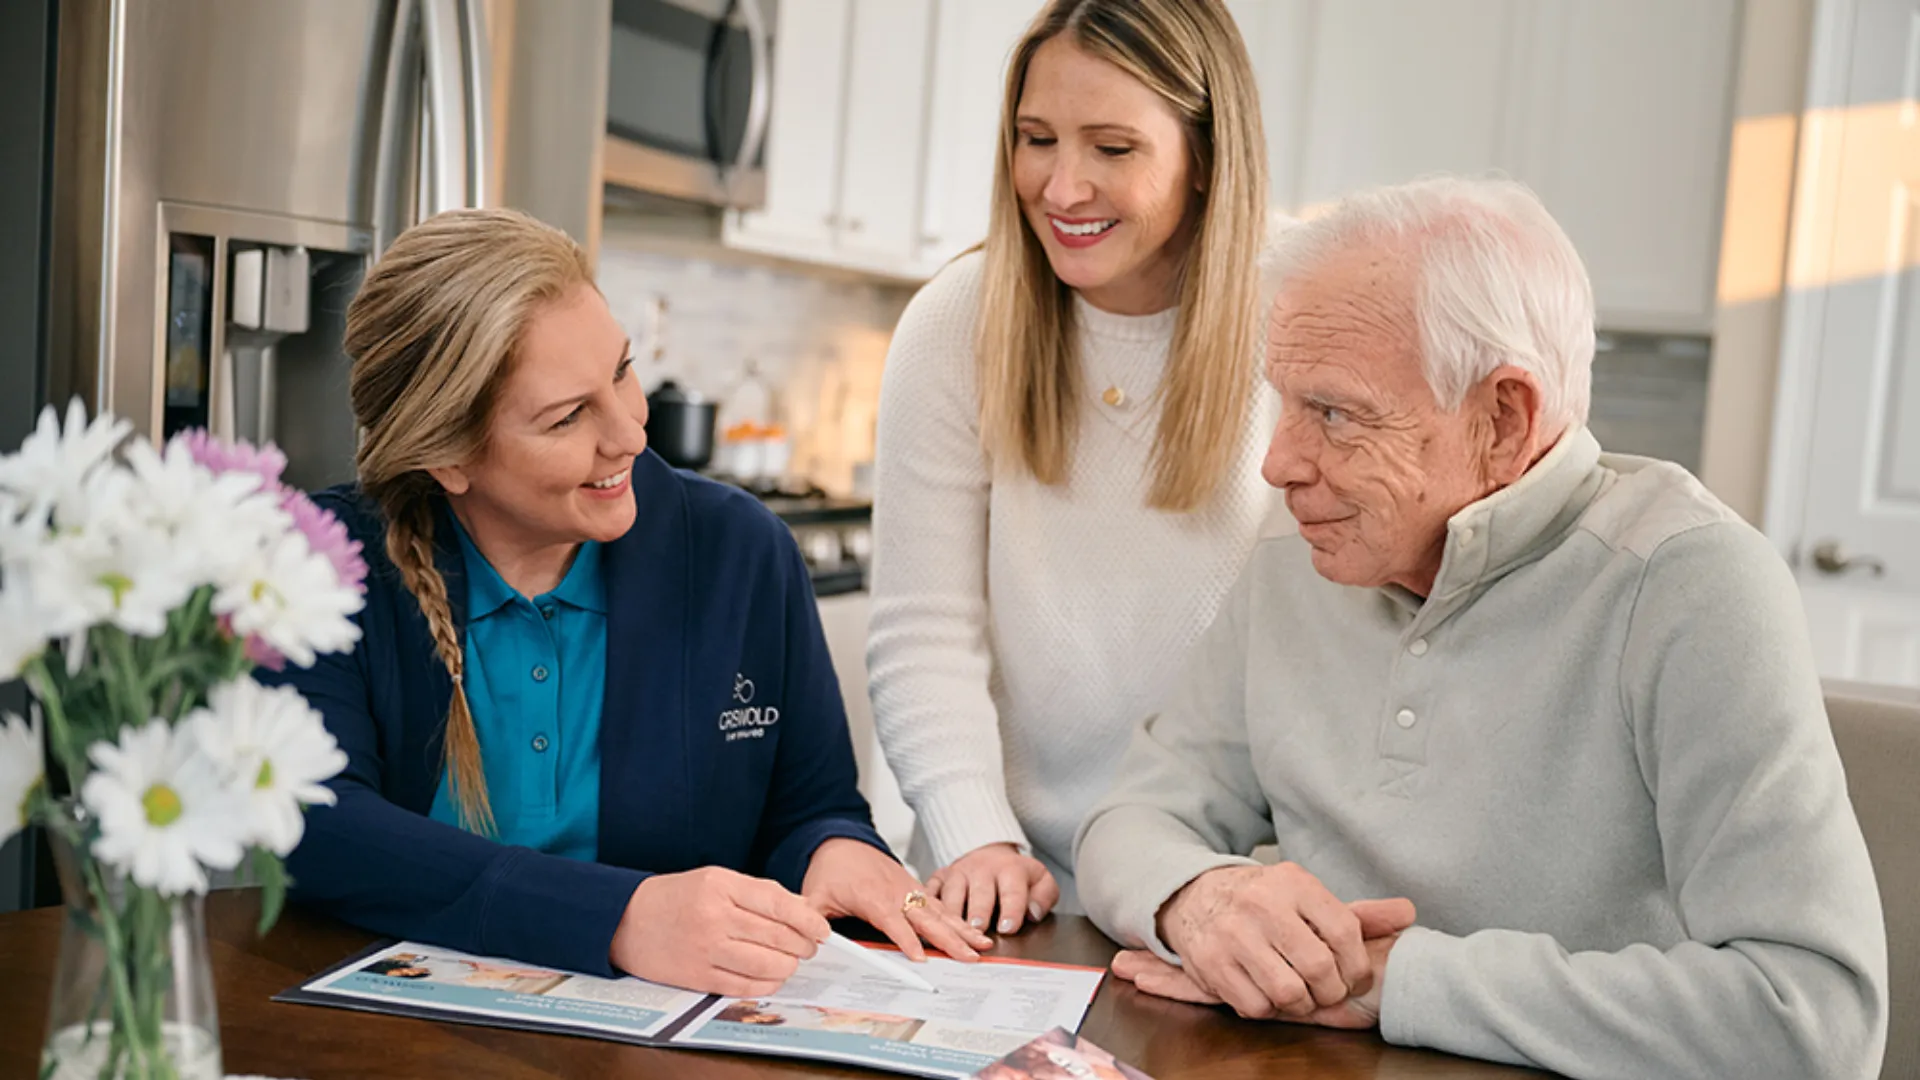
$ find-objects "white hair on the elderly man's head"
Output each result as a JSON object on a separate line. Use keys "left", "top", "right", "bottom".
{"left": 1277, "top": 177, "right": 1594, "bottom": 432}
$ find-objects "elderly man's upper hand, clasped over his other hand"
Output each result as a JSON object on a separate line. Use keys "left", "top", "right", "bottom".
{"left": 1158, "top": 863, "right": 1413, "bottom": 1020}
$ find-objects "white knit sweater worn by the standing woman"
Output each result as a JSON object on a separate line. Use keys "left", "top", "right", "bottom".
{"left": 868, "top": 245, "right": 1284, "bottom": 911}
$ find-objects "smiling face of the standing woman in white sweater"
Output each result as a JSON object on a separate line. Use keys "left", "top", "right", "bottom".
{"left": 1014, "top": 35, "right": 1196, "bottom": 315}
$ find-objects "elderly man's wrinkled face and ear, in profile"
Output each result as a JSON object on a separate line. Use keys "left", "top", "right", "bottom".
{"left": 1261, "top": 248, "right": 1524, "bottom": 596}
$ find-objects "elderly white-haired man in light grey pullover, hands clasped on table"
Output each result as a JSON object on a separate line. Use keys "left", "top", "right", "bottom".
{"left": 1075, "top": 179, "right": 1887, "bottom": 1078}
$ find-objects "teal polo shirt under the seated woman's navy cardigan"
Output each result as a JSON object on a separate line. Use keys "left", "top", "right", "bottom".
{"left": 430, "top": 525, "right": 607, "bottom": 861}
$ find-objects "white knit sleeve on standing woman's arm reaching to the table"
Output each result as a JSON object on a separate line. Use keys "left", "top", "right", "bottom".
{"left": 866, "top": 256, "right": 1027, "bottom": 871}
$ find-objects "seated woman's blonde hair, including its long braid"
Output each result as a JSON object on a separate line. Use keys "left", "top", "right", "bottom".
{"left": 346, "top": 209, "right": 593, "bottom": 834}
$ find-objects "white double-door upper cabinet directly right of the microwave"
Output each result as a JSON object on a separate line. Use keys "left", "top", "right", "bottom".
{"left": 724, "top": 0, "right": 935, "bottom": 277}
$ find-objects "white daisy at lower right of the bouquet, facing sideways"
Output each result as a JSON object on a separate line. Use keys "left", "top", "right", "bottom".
{"left": 186, "top": 678, "right": 348, "bottom": 857}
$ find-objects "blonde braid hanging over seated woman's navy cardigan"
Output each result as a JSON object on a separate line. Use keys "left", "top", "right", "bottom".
{"left": 386, "top": 498, "right": 495, "bottom": 836}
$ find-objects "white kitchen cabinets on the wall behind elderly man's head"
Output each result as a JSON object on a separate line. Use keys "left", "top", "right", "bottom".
{"left": 1233, "top": 0, "right": 1740, "bottom": 332}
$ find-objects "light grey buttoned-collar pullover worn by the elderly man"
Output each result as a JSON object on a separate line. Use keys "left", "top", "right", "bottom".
{"left": 1075, "top": 430, "right": 1887, "bottom": 1080}
